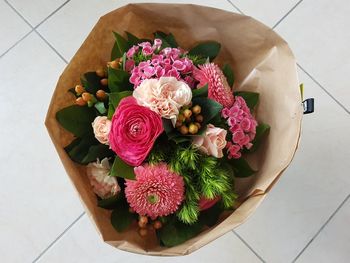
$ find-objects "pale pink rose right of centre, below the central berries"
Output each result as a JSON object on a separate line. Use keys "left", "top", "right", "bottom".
{"left": 193, "top": 124, "right": 227, "bottom": 158}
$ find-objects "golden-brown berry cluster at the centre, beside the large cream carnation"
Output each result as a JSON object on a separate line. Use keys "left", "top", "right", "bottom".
{"left": 175, "top": 105, "right": 203, "bottom": 135}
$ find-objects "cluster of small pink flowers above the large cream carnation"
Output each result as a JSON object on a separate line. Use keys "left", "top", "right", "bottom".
{"left": 125, "top": 39, "right": 195, "bottom": 88}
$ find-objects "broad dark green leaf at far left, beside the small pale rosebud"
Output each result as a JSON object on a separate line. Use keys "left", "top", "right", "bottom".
{"left": 56, "top": 105, "right": 96, "bottom": 137}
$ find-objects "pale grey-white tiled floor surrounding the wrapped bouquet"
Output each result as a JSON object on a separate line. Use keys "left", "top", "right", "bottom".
{"left": 0, "top": 0, "right": 350, "bottom": 263}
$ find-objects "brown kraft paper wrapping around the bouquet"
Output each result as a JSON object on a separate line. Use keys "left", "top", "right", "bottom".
{"left": 45, "top": 4, "right": 302, "bottom": 256}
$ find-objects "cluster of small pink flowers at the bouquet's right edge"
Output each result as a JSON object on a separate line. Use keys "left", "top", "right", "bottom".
{"left": 221, "top": 96, "right": 258, "bottom": 159}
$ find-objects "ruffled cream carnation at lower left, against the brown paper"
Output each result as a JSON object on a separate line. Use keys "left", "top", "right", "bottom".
{"left": 86, "top": 158, "right": 120, "bottom": 198}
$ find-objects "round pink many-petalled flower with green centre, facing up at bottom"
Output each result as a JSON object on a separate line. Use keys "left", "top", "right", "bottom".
{"left": 125, "top": 163, "right": 185, "bottom": 219}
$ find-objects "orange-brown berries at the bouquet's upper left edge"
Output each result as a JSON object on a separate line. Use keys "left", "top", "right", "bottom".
{"left": 74, "top": 68, "right": 108, "bottom": 107}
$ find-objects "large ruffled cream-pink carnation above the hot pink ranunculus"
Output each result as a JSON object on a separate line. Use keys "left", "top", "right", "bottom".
{"left": 133, "top": 77, "right": 192, "bottom": 125}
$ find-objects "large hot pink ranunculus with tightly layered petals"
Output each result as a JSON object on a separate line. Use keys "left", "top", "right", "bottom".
{"left": 109, "top": 96, "right": 163, "bottom": 166}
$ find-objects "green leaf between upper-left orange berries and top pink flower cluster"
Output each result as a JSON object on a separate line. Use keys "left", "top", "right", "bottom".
{"left": 108, "top": 67, "right": 133, "bottom": 92}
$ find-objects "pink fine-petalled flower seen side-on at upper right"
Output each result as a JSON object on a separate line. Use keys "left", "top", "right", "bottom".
{"left": 193, "top": 63, "right": 234, "bottom": 108}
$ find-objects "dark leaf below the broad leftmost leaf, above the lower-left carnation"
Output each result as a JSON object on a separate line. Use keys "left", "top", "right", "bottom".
{"left": 65, "top": 134, "right": 99, "bottom": 164}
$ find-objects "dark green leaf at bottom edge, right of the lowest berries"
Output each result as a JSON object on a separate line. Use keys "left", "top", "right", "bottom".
{"left": 157, "top": 219, "right": 203, "bottom": 247}
